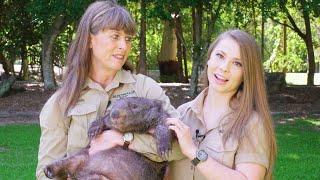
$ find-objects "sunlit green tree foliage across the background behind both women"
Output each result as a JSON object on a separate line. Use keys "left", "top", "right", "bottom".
{"left": 0, "top": 0, "right": 320, "bottom": 91}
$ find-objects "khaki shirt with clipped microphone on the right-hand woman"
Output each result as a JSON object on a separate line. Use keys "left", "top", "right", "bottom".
{"left": 134, "top": 89, "right": 269, "bottom": 180}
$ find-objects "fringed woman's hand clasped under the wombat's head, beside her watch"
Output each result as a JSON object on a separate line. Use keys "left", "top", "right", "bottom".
{"left": 89, "top": 130, "right": 123, "bottom": 154}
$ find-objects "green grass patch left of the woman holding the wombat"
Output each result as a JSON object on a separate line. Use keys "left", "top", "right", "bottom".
{"left": 0, "top": 125, "right": 40, "bottom": 180}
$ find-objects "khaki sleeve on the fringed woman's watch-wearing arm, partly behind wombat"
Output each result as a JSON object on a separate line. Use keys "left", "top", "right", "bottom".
{"left": 130, "top": 74, "right": 184, "bottom": 162}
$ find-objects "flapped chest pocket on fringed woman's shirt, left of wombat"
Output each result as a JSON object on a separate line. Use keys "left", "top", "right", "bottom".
{"left": 68, "top": 103, "right": 98, "bottom": 153}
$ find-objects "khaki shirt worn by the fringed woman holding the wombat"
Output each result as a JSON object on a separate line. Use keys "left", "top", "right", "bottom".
{"left": 36, "top": 70, "right": 178, "bottom": 179}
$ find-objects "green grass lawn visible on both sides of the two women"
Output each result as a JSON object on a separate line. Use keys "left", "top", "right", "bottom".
{"left": 0, "top": 117, "right": 320, "bottom": 180}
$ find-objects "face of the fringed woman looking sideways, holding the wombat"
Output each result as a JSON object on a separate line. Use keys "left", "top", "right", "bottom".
{"left": 90, "top": 29, "right": 132, "bottom": 71}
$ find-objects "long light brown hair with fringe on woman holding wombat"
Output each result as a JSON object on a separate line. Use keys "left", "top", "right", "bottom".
{"left": 59, "top": 1, "right": 136, "bottom": 115}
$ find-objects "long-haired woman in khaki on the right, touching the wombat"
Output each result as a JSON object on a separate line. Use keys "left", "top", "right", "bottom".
{"left": 101, "top": 30, "right": 277, "bottom": 180}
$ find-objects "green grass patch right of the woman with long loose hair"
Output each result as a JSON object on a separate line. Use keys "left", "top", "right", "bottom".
{"left": 275, "top": 118, "right": 320, "bottom": 179}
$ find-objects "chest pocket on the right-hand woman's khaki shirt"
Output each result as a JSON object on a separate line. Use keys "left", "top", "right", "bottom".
{"left": 205, "top": 132, "right": 238, "bottom": 168}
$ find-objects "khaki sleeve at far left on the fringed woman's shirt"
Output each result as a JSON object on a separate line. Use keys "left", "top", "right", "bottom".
{"left": 36, "top": 93, "right": 70, "bottom": 180}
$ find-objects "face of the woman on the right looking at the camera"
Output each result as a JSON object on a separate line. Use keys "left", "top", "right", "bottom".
{"left": 207, "top": 38, "right": 243, "bottom": 95}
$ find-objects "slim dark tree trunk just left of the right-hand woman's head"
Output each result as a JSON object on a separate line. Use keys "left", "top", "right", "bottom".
{"left": 190, "top": 1, "right": 203, "bottom": 97}
